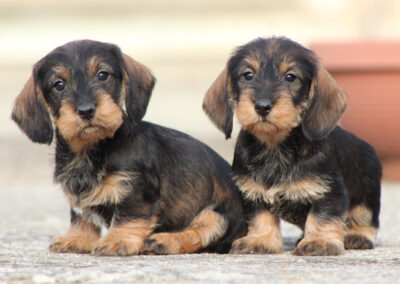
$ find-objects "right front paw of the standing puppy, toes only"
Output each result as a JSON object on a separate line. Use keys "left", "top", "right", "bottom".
{"left": 294, "top": 239, "right": 344, "bottom": 256}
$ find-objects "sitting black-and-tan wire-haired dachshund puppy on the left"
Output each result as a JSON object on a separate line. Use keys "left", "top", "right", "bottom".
{"left": 12, "top": 40, "right": 246, "bottom": 255}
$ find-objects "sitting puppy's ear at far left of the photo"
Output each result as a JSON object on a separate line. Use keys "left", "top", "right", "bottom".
{"left": 11, "top": 75, "right": 53, "bottom": 144}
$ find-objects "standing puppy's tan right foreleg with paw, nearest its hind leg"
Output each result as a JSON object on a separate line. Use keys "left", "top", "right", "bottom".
{"left": 294, "top": 213, "right": 344, "bottom": 256}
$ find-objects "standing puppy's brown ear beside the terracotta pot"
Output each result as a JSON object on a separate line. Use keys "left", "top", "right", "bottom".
{"left": 302, "top": 63, "right": 347, "bottom": 140}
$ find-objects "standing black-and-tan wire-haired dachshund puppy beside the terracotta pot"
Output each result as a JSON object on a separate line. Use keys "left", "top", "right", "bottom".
{"left": 203, "top": 37, "right": 381, "bottom": 255}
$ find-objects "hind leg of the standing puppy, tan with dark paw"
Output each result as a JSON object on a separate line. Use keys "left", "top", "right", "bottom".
{"left": 344, "top": 205, "right": 378, "bottom": 249}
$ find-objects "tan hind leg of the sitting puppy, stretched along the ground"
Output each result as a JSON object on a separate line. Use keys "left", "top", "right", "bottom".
{"left": 143, "top": 209, "right": 228, "bottom": 254}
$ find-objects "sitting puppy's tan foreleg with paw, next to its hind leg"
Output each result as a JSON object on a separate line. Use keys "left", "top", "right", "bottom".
{"left": 93, "top": 220, "right": 154, "bottom": 256}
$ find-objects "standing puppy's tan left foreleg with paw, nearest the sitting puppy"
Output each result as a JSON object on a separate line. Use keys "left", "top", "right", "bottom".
{"left": 230, "top": 211, "right": 283, "bottom": 254}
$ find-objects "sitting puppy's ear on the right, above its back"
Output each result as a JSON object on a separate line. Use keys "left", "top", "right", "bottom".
{"left": 122, "top": 54, "right": 156, "bottom": 122}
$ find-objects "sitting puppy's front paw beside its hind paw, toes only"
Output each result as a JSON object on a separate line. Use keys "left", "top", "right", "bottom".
{"left": 92, "top": 236, "right": 143, "bottom": 256}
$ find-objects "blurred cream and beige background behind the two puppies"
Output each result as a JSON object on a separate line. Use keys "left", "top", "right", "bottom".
{"left": 0, "top": 0, "right": 400, "bottom": 180}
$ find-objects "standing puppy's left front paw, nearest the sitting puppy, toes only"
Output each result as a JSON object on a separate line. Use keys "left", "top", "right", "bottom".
{"left": 229, "top": 236, "right": 283, "bottom": 254}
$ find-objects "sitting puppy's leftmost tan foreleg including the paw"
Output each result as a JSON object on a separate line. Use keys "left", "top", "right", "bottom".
{"left": 50, "top": 219, "right": 101, "bottom": 253}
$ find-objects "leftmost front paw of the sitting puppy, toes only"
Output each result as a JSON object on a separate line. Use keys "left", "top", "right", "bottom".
{"left": 49, "top": 235, "right": 95, "bottom": 253}
